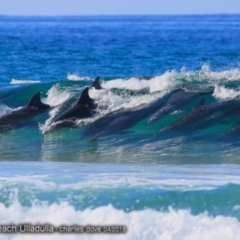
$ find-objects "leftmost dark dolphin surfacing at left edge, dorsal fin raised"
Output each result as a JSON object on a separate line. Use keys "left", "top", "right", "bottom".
{"left": 0, "top": 92, "right": 50, "bottom": 125}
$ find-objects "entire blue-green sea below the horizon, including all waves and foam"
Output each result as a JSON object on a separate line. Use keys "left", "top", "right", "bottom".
{"left": 0, "top": 15, "right": 240, "bottom": 240}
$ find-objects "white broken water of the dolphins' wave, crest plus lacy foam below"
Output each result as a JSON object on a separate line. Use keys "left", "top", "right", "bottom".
{"left": 37, "top": 65, "right": 240, "bottom": 133}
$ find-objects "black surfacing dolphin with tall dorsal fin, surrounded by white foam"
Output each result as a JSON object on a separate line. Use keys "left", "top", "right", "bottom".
{"left": 53, "top": 87, "right": 96, "bottom": 122}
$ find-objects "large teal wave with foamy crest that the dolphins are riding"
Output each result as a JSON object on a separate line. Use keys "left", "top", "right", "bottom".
{"left": 0, "top": 69, "right": 240, "bottom": 164}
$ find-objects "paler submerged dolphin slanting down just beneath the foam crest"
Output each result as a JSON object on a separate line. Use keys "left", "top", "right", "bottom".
{"left": 147, "top": 86, "right": 213, "bottom": 125}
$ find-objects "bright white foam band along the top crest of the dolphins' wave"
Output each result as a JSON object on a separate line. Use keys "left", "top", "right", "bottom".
{"left": 97, "top": 65, "right": 240, "bottom": 97}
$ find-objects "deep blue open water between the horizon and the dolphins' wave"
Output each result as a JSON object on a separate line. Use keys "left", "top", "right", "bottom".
{"left": 0, "top": 15, "right": 240, "bottom": 82}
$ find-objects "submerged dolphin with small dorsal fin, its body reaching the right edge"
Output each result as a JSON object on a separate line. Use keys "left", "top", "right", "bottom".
{"left": 160, "top": 99, "right": 240, "bottom": 132}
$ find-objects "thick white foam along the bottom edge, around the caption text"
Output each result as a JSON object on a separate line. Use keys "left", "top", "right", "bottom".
{"left": 0, "top": 200, "right": 240, "bottom": 240}
